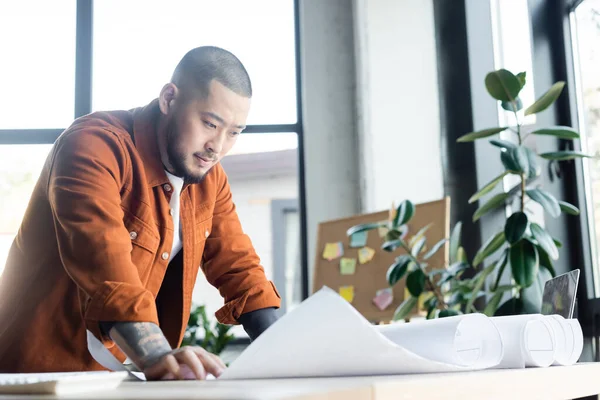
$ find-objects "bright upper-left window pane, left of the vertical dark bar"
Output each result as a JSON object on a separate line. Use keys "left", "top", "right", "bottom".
{"left": 0, "top": 0, "right": 75, "bottom": 129}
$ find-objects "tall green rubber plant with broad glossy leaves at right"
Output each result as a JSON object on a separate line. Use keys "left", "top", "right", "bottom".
{"left": 458, "top": 69, "right": 589, "bottom": 315}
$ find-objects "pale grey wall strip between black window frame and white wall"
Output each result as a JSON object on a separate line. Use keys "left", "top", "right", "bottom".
{"left": 300, "top": 0, "right": 360, "bottom": 285}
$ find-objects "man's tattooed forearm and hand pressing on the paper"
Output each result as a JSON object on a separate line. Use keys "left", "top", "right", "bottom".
{"left": 103, "top": 322, "right": 226, "bottom": 380}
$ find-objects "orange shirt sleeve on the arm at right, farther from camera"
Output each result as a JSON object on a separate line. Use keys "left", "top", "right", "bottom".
{"left": 202, "top": 168, "right": 281, "bottom": 325}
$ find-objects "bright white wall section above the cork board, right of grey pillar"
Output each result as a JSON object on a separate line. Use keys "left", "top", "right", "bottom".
{"left": 354, "top": 0, "right": 444, "bottom": 212}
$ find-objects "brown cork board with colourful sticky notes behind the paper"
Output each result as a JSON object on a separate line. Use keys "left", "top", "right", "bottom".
{"left": 312, "top": 197, "right": 450, "bottom": 323}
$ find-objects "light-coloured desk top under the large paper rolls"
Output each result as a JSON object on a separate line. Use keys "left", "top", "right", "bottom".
{"left": 0, "top": 363, "right": 600, "bottom": 400}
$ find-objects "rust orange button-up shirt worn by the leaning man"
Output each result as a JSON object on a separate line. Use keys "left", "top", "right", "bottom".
{"left": 0, "top": 100, "right": 280, "bottom": 372}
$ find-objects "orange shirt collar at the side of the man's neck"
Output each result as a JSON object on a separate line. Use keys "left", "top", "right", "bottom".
{"left": 133, "top": 99, "right": 169, "bottom": 187}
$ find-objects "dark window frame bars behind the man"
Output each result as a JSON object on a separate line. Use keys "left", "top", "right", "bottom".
{"left": 0, "top": 0, "right": 309, "bottom": 314}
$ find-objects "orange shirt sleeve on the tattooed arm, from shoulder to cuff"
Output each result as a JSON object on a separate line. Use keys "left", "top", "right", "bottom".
{"left": 48, "top": 129, "right": 158, "bottom": 345}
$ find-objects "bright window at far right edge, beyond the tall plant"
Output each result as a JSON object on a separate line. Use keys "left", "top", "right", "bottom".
{"left": 571, "top": 0, "right": 600, "bottom": 297}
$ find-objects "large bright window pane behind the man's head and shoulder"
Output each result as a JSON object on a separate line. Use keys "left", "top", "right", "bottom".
{"left": 92, "top": 0, "right": 296, "bottom": 124}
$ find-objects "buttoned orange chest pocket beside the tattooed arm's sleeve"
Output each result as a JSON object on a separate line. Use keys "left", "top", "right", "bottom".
{"left": 124, "top": 214, "right": 160, "bottom": 282}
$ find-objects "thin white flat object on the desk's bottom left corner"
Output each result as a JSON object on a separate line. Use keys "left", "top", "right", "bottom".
{"left": 0, "top": 371, "right": 128, "bottom": 395}
